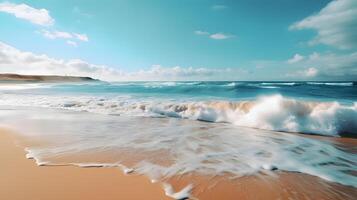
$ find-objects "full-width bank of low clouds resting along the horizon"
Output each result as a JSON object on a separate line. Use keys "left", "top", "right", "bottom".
{"left": 0, "top": 40, "right": 357, "bottom": 81}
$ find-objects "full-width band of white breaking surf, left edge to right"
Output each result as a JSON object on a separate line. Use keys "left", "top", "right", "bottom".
{"left": 0, "top": 94, "right": 357, "bottom": 136}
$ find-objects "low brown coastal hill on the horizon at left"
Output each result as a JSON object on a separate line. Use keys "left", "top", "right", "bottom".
{"left": 0, "top": 74, "right": 97, "bottom": 82}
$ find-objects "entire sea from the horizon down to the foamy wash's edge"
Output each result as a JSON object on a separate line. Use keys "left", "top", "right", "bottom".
{"left": 0, "top": 81, "right": 357, "bottom": 191}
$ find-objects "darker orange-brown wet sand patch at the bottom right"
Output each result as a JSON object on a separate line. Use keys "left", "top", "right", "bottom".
{"left": 167, "top": 172, "right": 357, "bottom": 200}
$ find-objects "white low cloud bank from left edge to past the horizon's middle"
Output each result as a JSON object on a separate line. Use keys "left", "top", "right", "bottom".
{"left": 0, "top": 42, "right": 245, "bottom": 81}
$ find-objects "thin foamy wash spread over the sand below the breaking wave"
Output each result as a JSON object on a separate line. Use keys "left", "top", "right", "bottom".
{"left": 0, "top": 106, "right": 357, "bottom": 187}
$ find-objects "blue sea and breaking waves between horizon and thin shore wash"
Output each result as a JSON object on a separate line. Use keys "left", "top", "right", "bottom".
{"left": 0, "top": 82, "right": 357, "bottom": 137}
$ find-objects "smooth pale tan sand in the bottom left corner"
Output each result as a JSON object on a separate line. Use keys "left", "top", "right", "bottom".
{"left": 0, "top": 129, "right": 170, "bottom": 200}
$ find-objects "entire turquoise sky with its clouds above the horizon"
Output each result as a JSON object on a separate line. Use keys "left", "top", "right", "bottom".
{"left": 0, "top": 0, "right": 357, "bottom": 81}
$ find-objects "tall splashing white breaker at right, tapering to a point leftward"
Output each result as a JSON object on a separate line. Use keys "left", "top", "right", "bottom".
{"left": 137, "top": 95, "right": 357, "bottom": 136}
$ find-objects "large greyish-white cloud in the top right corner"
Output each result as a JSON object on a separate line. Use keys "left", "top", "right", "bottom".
{"left": 290, "top": 0, "right": 357, "bottom": 49}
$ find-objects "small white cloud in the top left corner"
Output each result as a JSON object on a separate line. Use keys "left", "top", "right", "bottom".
{"left": 0, "top": 2, "right": 55, "bottom": 26}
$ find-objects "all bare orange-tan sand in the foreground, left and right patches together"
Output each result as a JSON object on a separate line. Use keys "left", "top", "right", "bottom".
{"left": 0, "top": 129, "right": 357, "bottom": 200}
